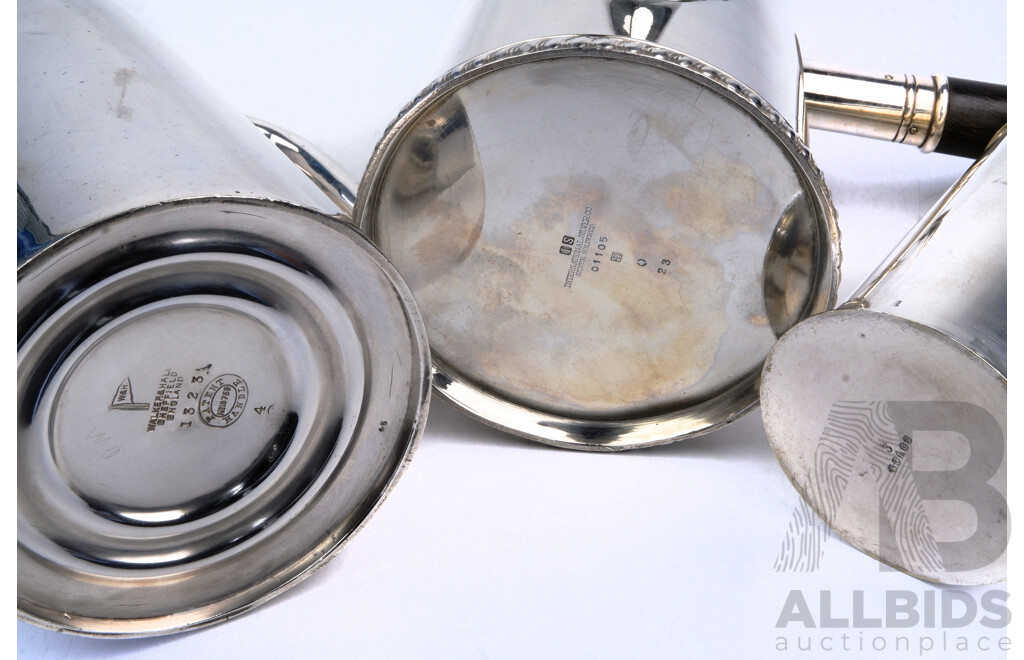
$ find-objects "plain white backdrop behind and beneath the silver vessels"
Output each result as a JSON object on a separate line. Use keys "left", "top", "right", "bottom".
{"left": 17, "top": 0, "right": 1007, "bottom": 659}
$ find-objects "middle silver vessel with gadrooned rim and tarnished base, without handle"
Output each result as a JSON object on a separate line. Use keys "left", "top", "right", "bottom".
{"left": 355, "top": 2, "right": 839, "bottom": 449}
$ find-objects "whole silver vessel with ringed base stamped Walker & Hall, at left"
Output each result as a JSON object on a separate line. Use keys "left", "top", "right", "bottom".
{"left": 16, "top": 0, "right": 429, "bottom": 635}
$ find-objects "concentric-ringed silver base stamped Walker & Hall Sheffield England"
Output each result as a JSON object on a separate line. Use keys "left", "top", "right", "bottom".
{"left": 17, "top": 201, "right": 429, "bottom": 634}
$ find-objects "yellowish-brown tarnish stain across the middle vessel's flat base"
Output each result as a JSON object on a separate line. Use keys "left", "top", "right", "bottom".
{"left": 392, "top": 177, "right": 731, "bottom": 415}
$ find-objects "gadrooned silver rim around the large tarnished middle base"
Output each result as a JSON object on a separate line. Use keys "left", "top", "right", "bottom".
{"left": 354, "top": 35, "right": 842, "bottom": 450}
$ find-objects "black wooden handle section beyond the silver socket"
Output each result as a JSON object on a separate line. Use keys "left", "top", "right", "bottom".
{"left": 935, "top": 78, "right": 1007, "bottom": 159}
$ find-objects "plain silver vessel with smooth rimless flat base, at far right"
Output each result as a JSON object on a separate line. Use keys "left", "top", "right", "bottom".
{"left": 761, "top": 129, "right": 1009, "bottom": 584}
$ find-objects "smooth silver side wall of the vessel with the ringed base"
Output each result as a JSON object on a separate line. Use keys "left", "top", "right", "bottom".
{"left": 17, "top": 1, "right": 338, "bottom": 261}
